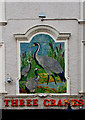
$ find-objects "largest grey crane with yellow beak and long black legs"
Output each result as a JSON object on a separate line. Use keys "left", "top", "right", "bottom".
{"left": 30, "top": 42, "right": 66, "bottom": 84}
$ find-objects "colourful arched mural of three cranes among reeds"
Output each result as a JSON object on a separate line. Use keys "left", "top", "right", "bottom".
{"left": 19, "top": 34, "right": 67, "bottom": 93}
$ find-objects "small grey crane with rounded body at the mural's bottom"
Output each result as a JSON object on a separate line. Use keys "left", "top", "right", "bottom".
{"left": 25, "top": 68, "right": 40, "bottom": 93}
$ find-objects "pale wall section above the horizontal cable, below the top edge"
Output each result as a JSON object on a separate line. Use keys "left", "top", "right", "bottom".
{"left": 6, "top": 2, "right": 80, "bottom": 20}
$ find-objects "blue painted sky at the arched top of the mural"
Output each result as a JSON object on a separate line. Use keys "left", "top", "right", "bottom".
{"left": 20, "top": 34, "right": 64, "bottom": 55}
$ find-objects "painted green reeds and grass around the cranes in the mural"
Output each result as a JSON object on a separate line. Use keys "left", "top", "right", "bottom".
{"left": 19, "top": 40, "right": 67, "bottom": 93}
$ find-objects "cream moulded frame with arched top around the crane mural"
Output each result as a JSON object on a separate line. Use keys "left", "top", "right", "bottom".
{"left": 14, "top": 25, "right": 71, "bottom": 95}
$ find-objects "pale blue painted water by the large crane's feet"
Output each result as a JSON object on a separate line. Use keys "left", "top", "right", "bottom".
{"left": 38, "top": 82, "right": 65, "bottom": 90}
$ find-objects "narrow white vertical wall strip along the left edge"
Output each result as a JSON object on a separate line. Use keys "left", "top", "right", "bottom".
{"left": 0, "top": 0, "right": 6, "bottom": 94}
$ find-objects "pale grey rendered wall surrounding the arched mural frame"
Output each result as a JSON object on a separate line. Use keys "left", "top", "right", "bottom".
{"left": 2, "top": 2, "right": 84, "bottom": 109}
